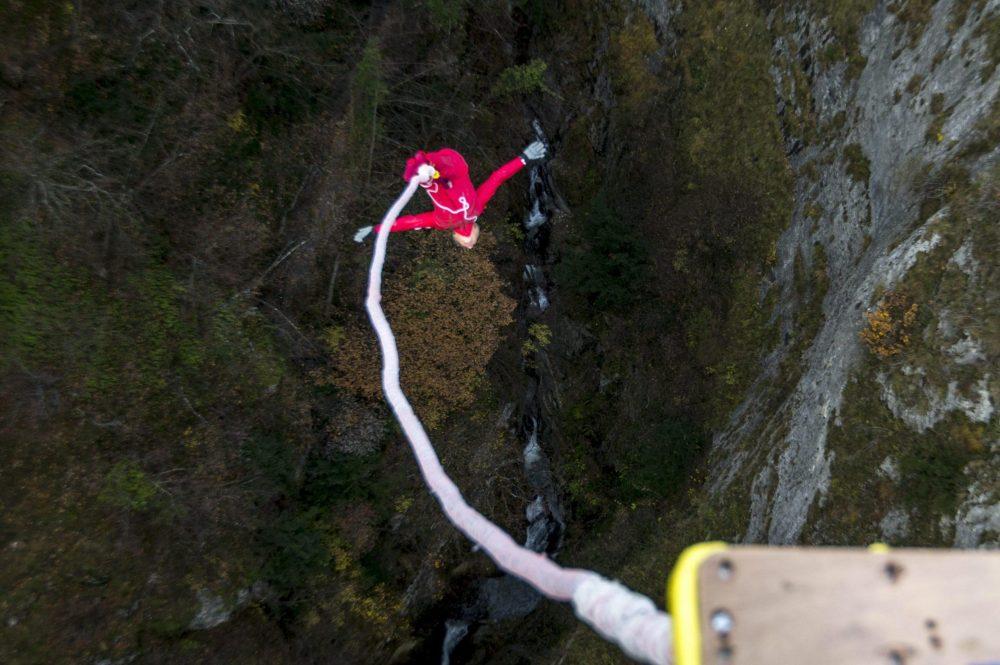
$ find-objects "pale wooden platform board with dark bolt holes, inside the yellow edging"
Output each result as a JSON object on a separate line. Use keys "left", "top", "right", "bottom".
{"left": 697, "top": 547, "right": 1000, "bottom": 665}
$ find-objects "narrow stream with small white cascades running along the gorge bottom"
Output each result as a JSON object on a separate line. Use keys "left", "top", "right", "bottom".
{"left": 441, "top": 121, "right": 566, "bottom": 665}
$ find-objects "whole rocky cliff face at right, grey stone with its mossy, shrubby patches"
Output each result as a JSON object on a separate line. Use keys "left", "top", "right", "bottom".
{"left": 709, "top": 0, "right": 1000, "bottom": 547}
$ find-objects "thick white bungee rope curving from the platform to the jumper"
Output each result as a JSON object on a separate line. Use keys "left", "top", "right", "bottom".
{"left": 365, "top": 167, "right": 673, "bottom": 665}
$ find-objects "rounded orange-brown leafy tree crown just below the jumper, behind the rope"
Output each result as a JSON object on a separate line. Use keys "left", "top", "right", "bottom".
{"left": 321, "top": 232, "right": 516, "bottom": 427}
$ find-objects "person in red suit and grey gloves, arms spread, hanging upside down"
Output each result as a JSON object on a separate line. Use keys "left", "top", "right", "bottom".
{"left": 354, "top": 141, "right": 548, "bottom": 249}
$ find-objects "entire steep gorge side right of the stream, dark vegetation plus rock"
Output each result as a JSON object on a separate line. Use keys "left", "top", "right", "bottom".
{"left": 519, "top": 1, "right": 998, "bottom": 662}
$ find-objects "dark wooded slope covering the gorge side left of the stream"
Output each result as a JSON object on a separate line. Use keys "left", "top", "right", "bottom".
{"left": 0, "top": 0, "right": 528, "bottom": 662}
